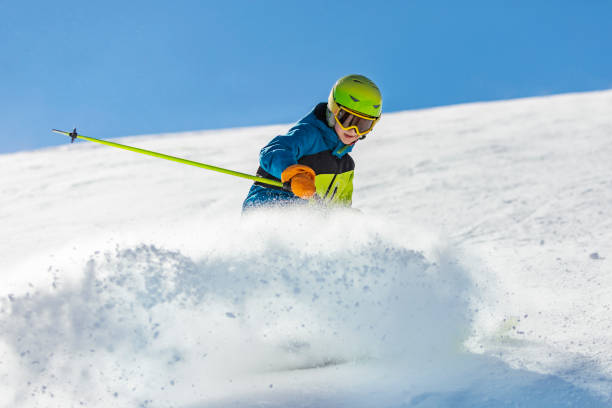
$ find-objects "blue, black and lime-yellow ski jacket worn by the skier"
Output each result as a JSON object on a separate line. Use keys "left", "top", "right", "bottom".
{"left": 242, "top": 102, "right": 355, "bottom": 211}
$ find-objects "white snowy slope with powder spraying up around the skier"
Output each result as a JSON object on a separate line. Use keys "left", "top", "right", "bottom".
{"left": 0, "top": 91, "right": 612, "bottom": 407}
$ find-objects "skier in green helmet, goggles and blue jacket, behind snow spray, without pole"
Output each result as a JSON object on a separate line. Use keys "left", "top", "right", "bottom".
{"left": 242, "top": 75, "right": 382, "bottom": 212}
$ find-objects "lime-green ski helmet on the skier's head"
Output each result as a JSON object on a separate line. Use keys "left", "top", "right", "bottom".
{"left": 327, "top": 75, "right": 382, "bottom": 119}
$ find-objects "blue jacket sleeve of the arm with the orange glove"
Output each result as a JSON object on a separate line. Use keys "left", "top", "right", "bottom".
{"left": 259, "top": 124, "right": 317, "bottom": 179}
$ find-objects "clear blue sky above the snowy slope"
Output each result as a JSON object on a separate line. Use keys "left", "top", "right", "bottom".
{"left": 0, "top": 0, "right": 612, "bottom": 153}
